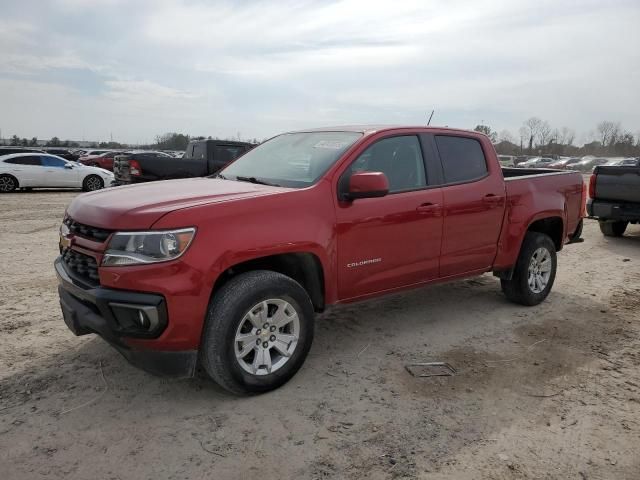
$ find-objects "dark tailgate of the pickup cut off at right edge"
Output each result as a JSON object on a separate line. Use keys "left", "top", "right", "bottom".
{"left": 593, "top": 167, "right": 640, "bottom": 203}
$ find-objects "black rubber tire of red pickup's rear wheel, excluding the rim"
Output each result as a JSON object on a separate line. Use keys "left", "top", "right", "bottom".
{"left": 500, "top": 232, "right": 558, "bottom": 306}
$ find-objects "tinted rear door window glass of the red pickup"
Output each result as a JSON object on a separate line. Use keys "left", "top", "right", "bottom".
{"left": 435, "top": 135, "right": 488, "bottom": 183}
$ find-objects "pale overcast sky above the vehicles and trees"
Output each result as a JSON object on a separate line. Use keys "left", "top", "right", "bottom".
{"left": 0, "top": 0, "right": 640, "bottom": 143}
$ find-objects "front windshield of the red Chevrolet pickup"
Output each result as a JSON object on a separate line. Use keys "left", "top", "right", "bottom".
{"left": 219, "top": 132, "right": 362, "bottom": 188}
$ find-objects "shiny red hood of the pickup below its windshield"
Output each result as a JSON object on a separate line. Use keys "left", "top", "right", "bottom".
{"left": 67, "top": 178, "right": 290, "bottom": 230}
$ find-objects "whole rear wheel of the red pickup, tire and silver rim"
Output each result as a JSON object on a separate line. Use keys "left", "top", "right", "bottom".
{"left": 500, "top": 232, "right": 558, "bottom": 306}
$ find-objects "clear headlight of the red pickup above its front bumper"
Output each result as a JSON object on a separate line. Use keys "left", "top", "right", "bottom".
{"left": 102, "top": 228, "right": 196, "bottom": 267}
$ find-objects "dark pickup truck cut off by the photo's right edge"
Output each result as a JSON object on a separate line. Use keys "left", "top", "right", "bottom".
{"left": 587, "top": 166, "right": 640, "bottom": 237}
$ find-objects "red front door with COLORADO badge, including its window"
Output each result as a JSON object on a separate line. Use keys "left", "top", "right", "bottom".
{"left": 336, "top": 135, "right": 443, "bottom": 300}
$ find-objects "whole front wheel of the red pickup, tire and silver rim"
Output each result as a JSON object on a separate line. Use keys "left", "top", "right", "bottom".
{"left": 200, "top": 270, "right": 314, "bottom": 394}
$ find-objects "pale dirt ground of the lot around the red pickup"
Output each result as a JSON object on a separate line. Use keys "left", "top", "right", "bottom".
{"left": 0, "top": 192, "right": 640, "bottom": 480}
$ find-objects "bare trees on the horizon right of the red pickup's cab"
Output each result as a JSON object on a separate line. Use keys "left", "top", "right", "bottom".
{"left": 474, "top": 117, "right": 640, "bottom": 157}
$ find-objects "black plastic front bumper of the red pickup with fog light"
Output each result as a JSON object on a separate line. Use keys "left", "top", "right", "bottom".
{"left": 54, "top": 257, "right": 198, "bottom": 377}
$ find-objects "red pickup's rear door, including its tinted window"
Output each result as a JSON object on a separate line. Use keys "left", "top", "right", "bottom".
{"left": 433, "top": 134, "right": 506, "bottom": 277}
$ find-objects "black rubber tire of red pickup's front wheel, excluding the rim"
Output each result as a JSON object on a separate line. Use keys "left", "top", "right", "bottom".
{"left": 200, "top": 270, "right": 314, "bottom": 395}
